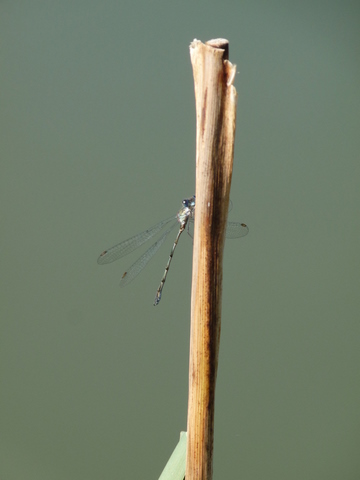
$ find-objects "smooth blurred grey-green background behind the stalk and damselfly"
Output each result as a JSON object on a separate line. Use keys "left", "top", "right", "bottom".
{"left": 0, "top": 0, "right": 360, "bottom": 480}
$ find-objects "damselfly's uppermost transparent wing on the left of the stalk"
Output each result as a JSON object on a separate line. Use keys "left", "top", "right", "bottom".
{"left": 97, "top": 216, "right": 177, "bottom": 265}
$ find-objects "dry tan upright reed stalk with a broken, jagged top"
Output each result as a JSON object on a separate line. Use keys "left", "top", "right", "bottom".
{"left": 186, "top": 39, "right": 237, "bottom": 480}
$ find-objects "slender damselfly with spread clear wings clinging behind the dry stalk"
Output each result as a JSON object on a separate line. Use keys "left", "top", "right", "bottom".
{"left": 97, "top": 195, "right": 249, "bottom": 305}
